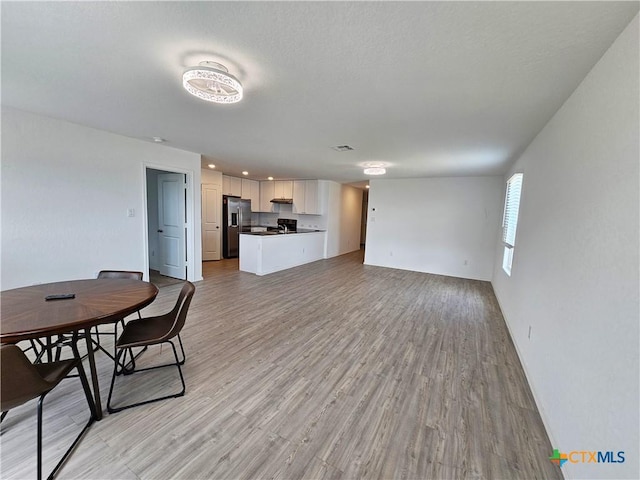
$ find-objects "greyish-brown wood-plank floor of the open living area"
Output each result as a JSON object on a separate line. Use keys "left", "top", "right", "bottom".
{"left": 1, "top": 252, "right": 562, "bottom": 480}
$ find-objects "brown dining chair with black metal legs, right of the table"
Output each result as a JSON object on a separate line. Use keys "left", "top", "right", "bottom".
{"left": 107, "top": 282, "right": 196, "bottom": 413}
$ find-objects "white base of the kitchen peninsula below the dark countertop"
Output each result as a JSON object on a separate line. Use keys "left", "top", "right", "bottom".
{"left": 240, "top": 230, "right": 327, "bottom": 275}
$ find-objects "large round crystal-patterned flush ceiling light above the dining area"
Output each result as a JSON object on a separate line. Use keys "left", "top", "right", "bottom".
{"left": 182, "top": 62, "right": 242, "bottom": 103}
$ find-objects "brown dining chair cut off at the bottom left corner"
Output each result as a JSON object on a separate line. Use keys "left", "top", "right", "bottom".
{"left": 0, "top": 336, "right": 96, "bottom": 480}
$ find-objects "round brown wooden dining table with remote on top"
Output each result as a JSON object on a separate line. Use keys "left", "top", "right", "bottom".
{"left": 0, "top": 278, "right": 158, "bottom": 420}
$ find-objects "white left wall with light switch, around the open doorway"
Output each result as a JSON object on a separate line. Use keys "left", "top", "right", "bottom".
{"left": 0, "top": 106, "right": 202, "bottom": 290}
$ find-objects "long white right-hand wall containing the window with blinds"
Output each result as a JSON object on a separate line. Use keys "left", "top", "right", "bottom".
{"left": 493, "top": 17, "right": 640, "bottom": 479}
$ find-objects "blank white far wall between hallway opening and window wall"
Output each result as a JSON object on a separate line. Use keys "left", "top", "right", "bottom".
{"left": 365, "top": 177, "right": 503, "bottom": 280}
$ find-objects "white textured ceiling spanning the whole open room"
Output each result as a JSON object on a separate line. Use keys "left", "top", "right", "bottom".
{"left": 1, "top": 2, "right": 639, "bottom": 182}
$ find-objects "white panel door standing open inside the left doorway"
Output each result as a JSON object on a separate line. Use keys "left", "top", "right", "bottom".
{"left": 158, "top": 173, "right": 187, "bottom": 280}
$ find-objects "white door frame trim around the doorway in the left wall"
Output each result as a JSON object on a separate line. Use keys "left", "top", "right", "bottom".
{"left": 142, "top": 162, "right": 202, "bottom": 282}
